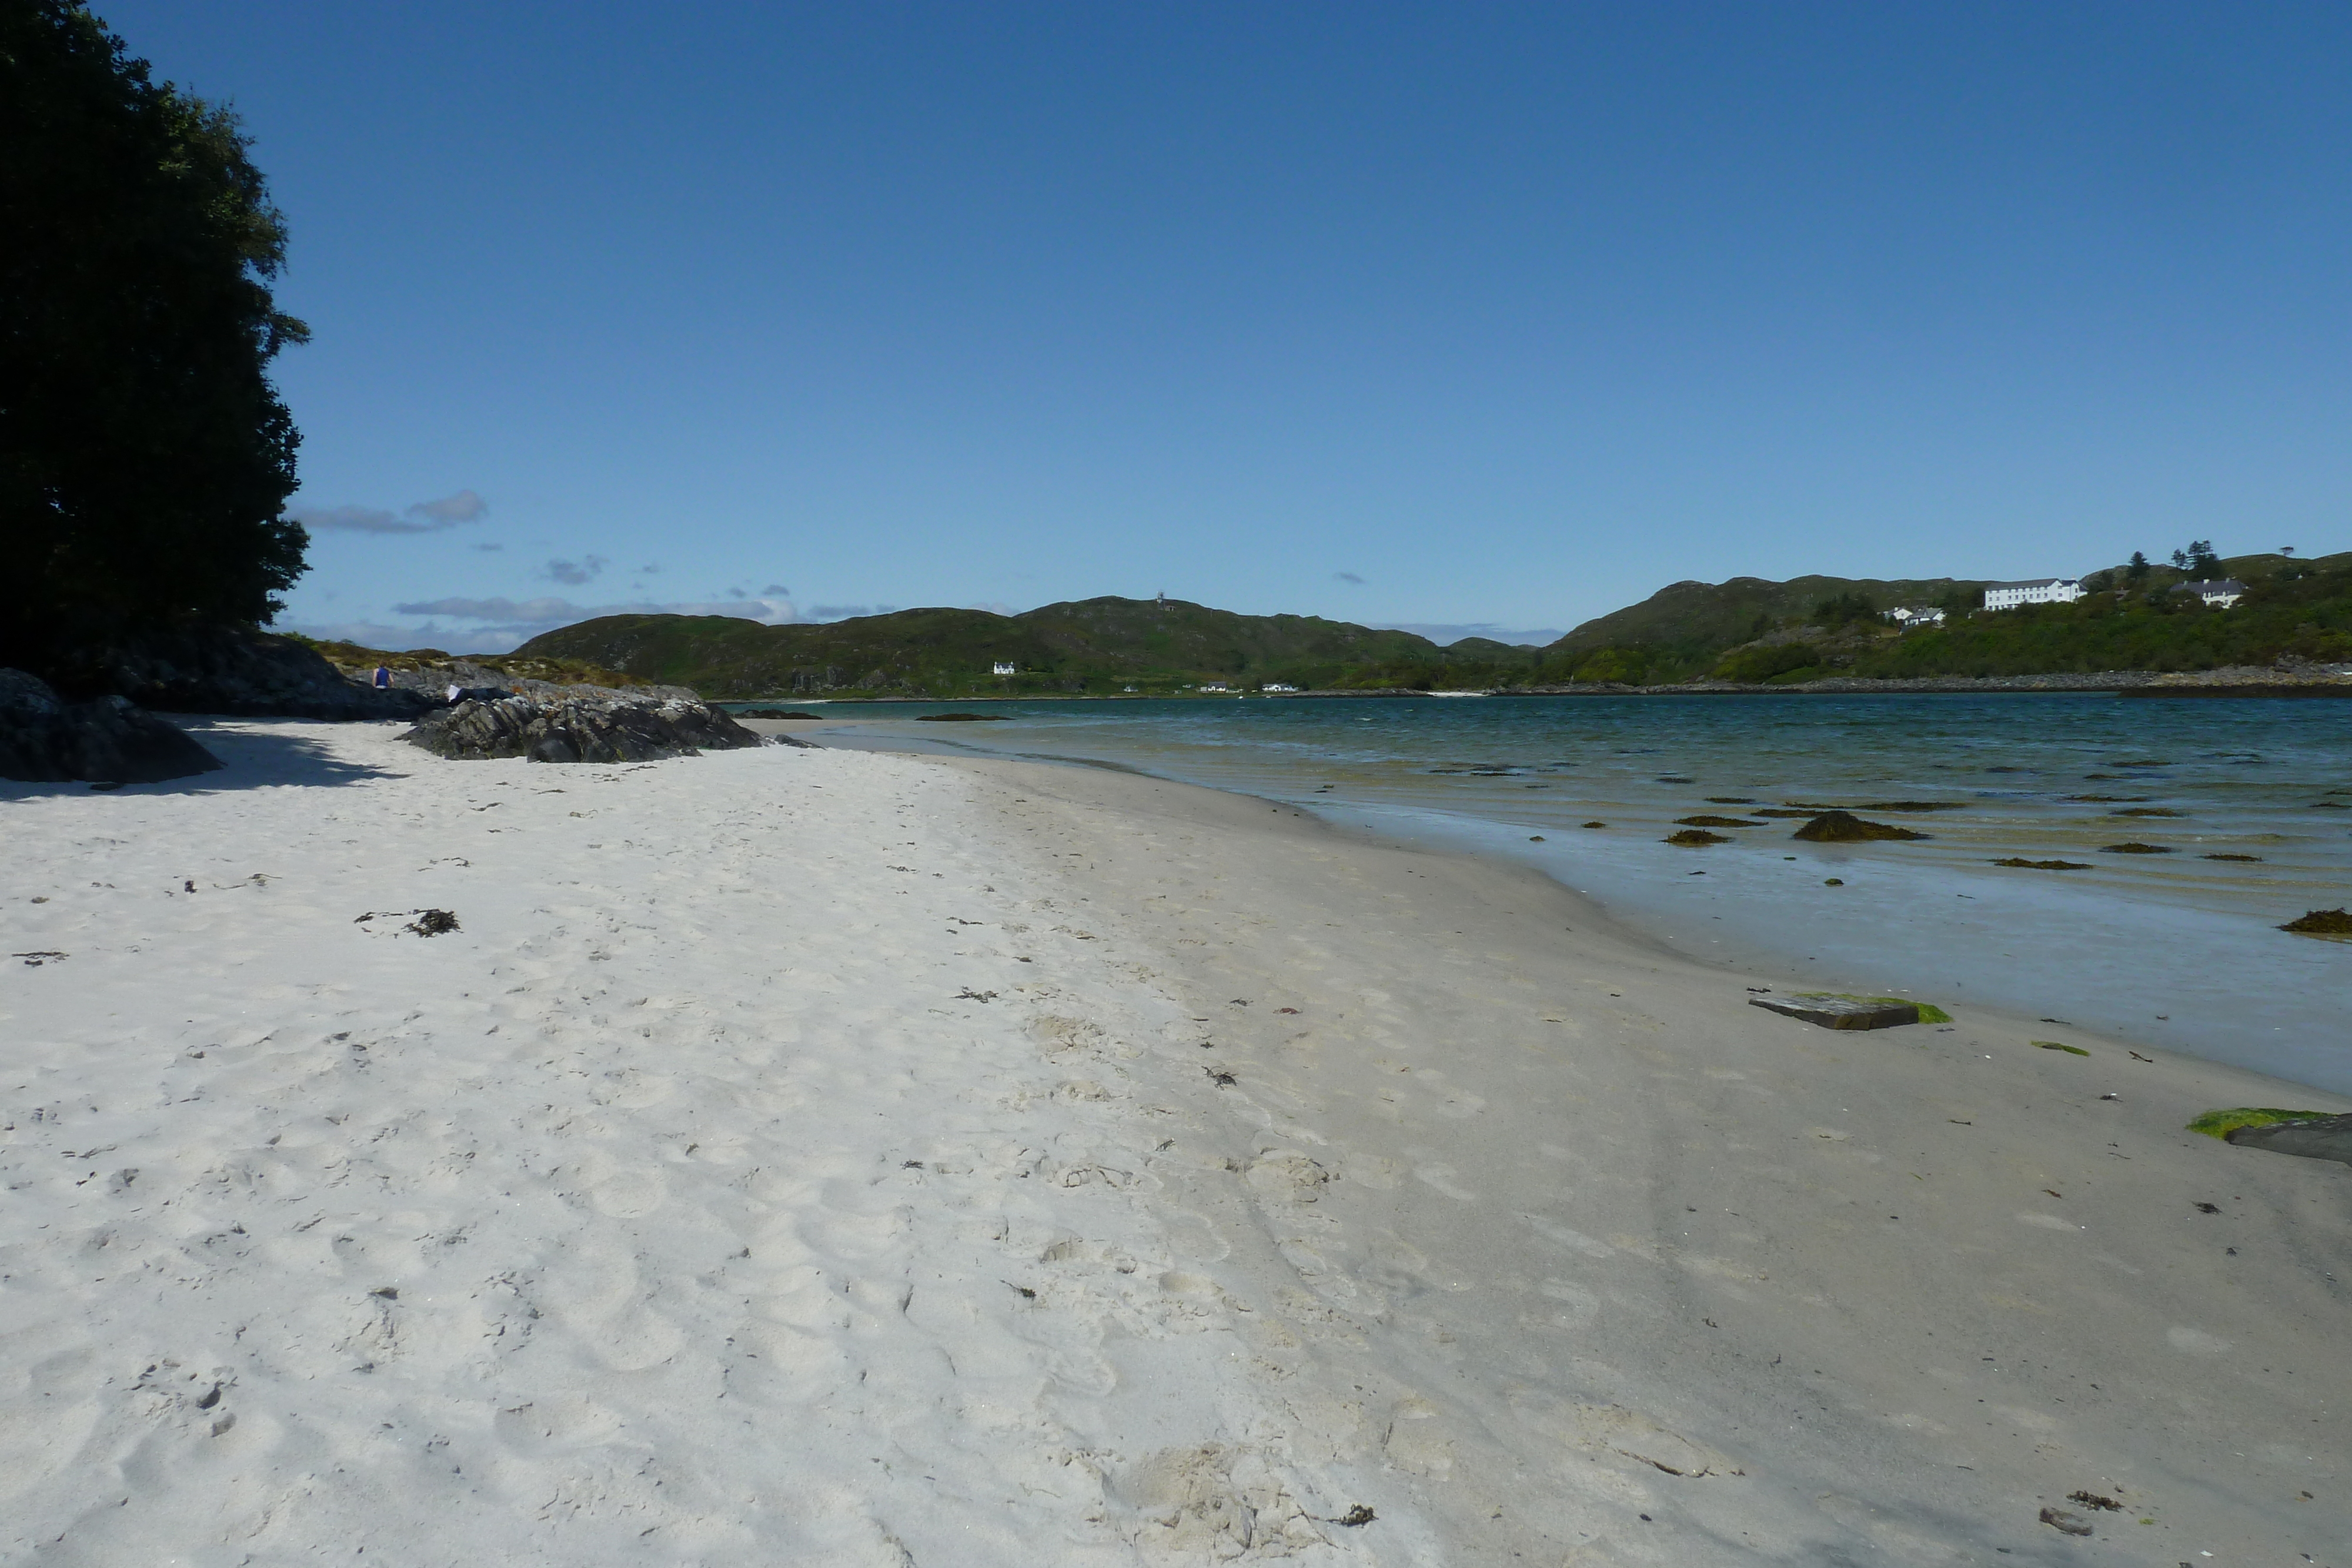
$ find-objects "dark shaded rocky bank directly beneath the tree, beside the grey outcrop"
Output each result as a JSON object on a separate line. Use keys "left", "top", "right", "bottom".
{"left": 54, "top": 626, "right": 433, "bottom": 720}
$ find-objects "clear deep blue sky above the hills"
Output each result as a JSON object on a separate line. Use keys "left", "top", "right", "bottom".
{"left": 99, "top": 0, "right": 2352, "bottom": 651}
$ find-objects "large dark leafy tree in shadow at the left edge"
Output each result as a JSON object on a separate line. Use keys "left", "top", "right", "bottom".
{"left": 0, "top": 0, "right": 308, "bottom": 668}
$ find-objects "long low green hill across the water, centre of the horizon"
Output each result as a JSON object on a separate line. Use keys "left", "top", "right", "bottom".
{"left": 517, "top": 597, "right": 1534, "bottom": 698}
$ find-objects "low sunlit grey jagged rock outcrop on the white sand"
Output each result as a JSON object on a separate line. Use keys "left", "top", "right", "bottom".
{"left": 402, "top": 691, "right": 776, "bottom": 762}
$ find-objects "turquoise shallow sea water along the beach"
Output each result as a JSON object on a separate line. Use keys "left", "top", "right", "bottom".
{"left": 753, "top": 694, "right": 2352, "bottom": 1093}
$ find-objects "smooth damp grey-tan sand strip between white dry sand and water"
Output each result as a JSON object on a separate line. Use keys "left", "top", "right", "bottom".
{"left": 953, "top": 762, "right": 2352, "bottom": 1563}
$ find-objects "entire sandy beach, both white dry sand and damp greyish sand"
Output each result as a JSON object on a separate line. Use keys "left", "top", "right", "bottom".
{"left": 0, "top": 722, "right": 2352, "bottom": 1568}
